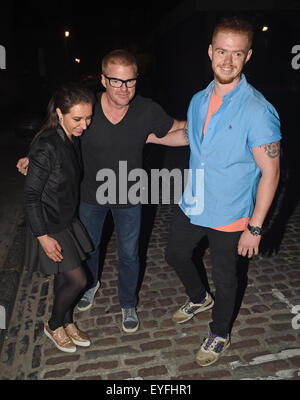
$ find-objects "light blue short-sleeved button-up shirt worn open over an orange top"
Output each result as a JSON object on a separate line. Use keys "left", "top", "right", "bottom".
{"left": 180, "top": 74, "right": 281, "bottom": 228}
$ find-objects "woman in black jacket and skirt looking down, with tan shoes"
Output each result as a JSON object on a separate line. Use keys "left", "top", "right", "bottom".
{"left": 24, "top": 83, "right": 94, "bottom": 353}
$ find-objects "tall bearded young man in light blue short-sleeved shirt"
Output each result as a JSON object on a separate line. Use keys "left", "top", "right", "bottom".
{"left": 151, "top": 18, "right": 281, "bottom": 366}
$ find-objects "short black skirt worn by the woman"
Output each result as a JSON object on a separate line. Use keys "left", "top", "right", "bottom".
{"left": 24, "top": 219, "right": 93, "bottom": 274}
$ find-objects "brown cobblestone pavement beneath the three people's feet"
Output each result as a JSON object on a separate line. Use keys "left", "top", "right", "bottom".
{"left": 0, "top": 184, "right": 300, "bottom": 381}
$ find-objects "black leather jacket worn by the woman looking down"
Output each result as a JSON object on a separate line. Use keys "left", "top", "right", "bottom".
{"left": 24, "top": 127, "right": 82, "bottom": 236}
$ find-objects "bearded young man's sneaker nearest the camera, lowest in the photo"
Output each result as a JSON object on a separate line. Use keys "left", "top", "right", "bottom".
{"left": 196, "top": 332, "right": 230, "bottom": 367}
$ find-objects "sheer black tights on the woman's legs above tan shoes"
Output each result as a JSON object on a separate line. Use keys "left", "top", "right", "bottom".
{"left": 49, "top": 267, "right": 87, "bottom": 331}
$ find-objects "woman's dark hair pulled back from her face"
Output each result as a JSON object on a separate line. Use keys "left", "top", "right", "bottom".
{"left": 31, "top": 82, "right": 96, "bottom": 143}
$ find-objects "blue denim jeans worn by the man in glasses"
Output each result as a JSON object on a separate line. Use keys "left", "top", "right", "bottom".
{"left": 79, "top": 202, "right": 141, "bottom": 308}
